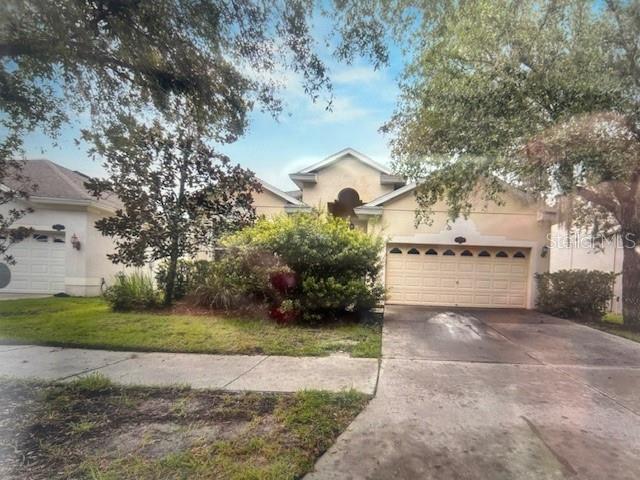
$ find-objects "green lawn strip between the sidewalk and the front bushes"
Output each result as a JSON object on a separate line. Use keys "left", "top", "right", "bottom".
{"left": 0, "top": 298, "right": 381, "bottom": 358}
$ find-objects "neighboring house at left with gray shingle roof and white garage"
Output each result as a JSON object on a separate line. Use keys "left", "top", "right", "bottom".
{"left": 0, "top": 160, "right": 127, "bottom": 298}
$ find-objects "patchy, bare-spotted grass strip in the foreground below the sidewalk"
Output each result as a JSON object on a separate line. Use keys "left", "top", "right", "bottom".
{"left": 0, "top": 376, "right": 368, "bottom": 480}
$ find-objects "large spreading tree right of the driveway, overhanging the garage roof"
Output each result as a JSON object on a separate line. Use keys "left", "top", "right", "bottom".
{"left": 384, "top": 0, "right": 640, "bottom": 327}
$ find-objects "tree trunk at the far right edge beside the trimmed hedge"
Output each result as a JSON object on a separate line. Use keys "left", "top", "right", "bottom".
{"left": 622, "top": 232, "right": 640, "bottom": 329}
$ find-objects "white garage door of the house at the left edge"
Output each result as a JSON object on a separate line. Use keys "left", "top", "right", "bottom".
{"left": 0, "top": 232, "right": 65, "bottom": 293}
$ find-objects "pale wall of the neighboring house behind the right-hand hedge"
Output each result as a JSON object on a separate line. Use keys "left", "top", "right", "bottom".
{"left": 549, "top": 225, "right": 624, "bottom": 313}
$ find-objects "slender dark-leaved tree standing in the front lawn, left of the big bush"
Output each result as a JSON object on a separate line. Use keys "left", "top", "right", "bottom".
{"left": 84, "top": 116, "right": 260, "bottom": 305}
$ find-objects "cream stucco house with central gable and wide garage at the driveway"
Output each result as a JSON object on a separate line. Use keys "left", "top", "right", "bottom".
{"left": 254, "top": 149, "right": 553, "bottom": 308}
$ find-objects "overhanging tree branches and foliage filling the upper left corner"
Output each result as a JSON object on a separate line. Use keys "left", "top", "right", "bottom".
{"left": 0, "top": 0, "right": 386, "bottom": 255}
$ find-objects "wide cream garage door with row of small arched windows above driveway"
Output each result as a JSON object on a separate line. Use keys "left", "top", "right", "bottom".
{"left": 386, "top": 244, "right": 530, "bottom": 307}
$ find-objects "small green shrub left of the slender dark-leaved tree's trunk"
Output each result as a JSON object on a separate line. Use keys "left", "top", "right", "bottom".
{"left": 104, "top": 272, "right": 162, "bottom": 311}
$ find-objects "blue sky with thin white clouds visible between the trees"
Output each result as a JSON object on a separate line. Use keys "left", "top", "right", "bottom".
{"left": 25, "top": 20, "right": 404, "bottom": 190}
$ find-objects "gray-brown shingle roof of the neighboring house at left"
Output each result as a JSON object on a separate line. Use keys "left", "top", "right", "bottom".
{"left": 2, "top": 160, "right": 122, "bottom": 209}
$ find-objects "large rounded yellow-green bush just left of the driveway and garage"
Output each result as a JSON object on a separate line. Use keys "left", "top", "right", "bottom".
{"left": 224, "top": 213, "right": 384, "bottom": 321}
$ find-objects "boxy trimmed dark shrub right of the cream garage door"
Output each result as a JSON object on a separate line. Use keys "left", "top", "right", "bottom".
{"left": 536, "top": 270, "right": 616, "bottom": 321}
